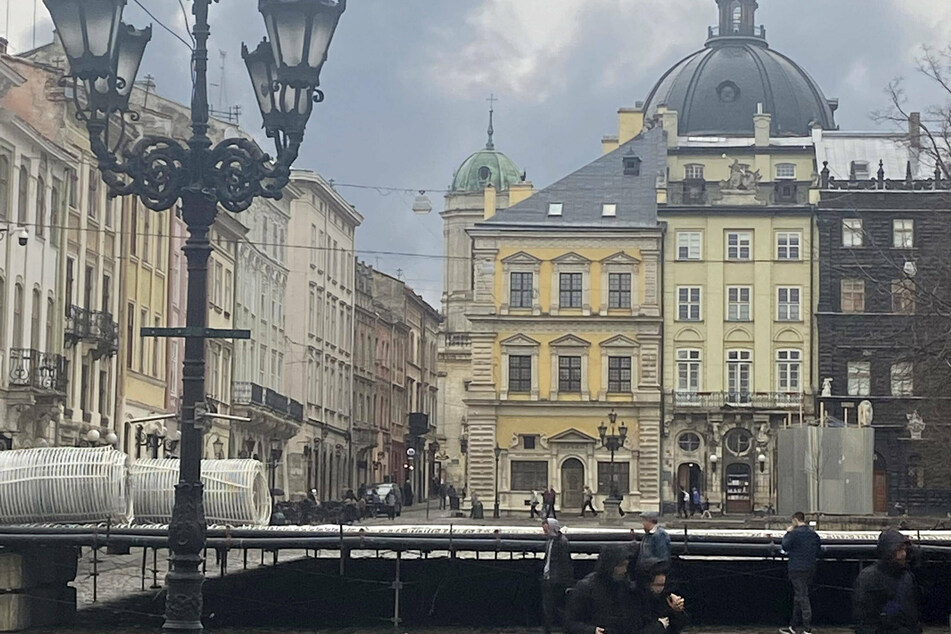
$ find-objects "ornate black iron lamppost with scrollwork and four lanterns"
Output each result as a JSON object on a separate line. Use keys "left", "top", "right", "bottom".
{"left": 43, "top": 0, "right": 346, "bottom": 632}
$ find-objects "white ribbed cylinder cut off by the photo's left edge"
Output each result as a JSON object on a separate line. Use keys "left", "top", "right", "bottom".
{"left": 0, "top": 447, "right": 132, "bottom": 524}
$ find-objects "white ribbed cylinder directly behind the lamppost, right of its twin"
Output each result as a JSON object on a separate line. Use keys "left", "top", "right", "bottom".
{"left": 131, "top": 459, "right": 271, "bottom": 526}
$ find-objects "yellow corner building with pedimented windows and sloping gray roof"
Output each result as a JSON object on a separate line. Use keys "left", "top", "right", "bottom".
{"left": 464, "top": 127, "right": 666, "bottom": 512}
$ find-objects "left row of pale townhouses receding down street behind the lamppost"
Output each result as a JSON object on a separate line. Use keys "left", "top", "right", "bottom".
{"left": 0, "top": 42, "right": 439, "bottom": 500}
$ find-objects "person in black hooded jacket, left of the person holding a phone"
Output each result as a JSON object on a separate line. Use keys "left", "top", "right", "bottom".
{"left": 565, "top": 544, "right": 644, "bottom": 634}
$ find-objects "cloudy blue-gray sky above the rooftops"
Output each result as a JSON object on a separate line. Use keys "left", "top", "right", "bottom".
{"left": 0, "top": 0, "right": 951, "bottom": 306}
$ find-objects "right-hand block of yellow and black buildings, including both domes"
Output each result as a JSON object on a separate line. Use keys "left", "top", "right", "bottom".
{"left": 436, "top": 0, "right": 951, "bottom": 515}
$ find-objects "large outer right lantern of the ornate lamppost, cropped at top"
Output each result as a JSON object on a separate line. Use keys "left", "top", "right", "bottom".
{"left": 258, "top": 0, "right": 347, "bottom": 88}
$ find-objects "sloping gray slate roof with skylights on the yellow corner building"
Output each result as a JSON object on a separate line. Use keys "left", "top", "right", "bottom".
{"left": 479, "top": 126, "right": 667, "bottom": 229}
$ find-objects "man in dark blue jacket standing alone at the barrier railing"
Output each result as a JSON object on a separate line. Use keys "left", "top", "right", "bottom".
{"left": 779, "top": 511, "right": 822, "bottom": 634}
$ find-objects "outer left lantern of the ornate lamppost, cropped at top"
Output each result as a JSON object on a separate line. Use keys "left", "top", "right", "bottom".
{"left": 43, "top": 0, "right": 126, "bottom": 80}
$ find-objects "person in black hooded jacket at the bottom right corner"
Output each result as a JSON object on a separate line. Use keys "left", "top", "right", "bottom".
{"left": 852, "top": 528, "right": 921, "bottom": 634}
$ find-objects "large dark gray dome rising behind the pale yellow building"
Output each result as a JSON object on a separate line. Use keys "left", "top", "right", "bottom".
{"left": 645, "top": 0, "right": 835, "bottom": 136}
